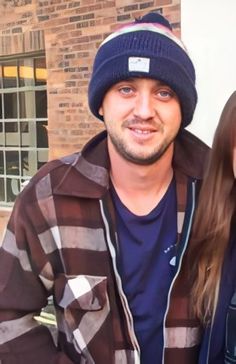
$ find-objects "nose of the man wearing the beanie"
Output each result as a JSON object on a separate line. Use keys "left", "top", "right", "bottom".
{"left": 134, "top": 93, "right": 155, "bottom": 120}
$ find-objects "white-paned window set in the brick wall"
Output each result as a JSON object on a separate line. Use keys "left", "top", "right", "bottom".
{"left": 0, "top": 56, "right": 48, "bottom": 207}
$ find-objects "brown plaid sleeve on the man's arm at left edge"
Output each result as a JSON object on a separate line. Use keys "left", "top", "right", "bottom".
{"left": 0, "top": 181, "right": 72, "bottom": 364}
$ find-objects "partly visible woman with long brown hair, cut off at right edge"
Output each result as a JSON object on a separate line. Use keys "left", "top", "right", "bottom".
{"left": 189, "top": 92, "right": 236, "bottom": 364}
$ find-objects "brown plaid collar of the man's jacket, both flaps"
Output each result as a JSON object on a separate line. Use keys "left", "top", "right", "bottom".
{"left": 50, "top": 129, "right": 209, "bottom": 198}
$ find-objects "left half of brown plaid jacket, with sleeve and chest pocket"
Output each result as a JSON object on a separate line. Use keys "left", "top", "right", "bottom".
{"left": 0, "top": 161, "right": 135, "bottom": 364}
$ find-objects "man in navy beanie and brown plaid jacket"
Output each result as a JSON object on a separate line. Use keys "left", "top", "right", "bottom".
{"left": 0, "top": 13, "right": 207, "bottom": 364}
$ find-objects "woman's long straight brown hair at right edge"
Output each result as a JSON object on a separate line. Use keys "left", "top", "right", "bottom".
{"left": 189, "top": 92, "right": 236, "bottom": 324}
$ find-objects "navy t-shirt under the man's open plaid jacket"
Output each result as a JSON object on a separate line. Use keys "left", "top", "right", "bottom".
{"left": 112, "top": 179, "right": 177, "bottom": 364}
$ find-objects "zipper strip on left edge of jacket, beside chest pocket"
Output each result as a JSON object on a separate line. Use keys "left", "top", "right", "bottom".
{"left": 99, "top": 200, "right": 140, "bottom": 364}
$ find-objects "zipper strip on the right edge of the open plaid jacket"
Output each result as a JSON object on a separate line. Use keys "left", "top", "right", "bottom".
{"left": 162, "top": 181, "right": 197, "bottom": 364}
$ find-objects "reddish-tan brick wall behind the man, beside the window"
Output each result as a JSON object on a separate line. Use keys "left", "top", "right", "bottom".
{"left": 0, "top": 0, "right": 181, "bottom": 236}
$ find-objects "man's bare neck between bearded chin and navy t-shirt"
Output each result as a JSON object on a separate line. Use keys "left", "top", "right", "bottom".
{"left": 109, "top": 145, "right": 173, "bottom": 216}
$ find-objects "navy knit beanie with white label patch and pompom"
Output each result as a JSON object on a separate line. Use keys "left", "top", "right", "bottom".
{"left": 88, "top": 13, "right": 197, "bottom": 127}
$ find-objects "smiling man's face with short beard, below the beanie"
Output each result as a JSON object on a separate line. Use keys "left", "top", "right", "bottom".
{"left": 99, "top": 78, "right": 181, "bottom": 165}
